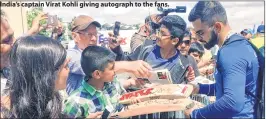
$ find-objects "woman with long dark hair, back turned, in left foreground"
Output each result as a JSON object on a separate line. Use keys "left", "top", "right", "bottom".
{"left": 1, "top": 35, "right": 69, "bottom": 119}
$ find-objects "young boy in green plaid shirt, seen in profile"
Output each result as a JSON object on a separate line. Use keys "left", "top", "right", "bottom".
{"left": 63, "top": 46, "right": 126, "bottom": 118}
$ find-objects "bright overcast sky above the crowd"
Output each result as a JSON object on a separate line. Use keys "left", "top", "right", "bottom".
{"left": 44, "top": 1, "right": 264, "bottom": 32}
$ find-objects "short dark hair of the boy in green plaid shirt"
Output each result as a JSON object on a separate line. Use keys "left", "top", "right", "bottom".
{"left": 81, "top": 46, "right": 116, "bottom": 80}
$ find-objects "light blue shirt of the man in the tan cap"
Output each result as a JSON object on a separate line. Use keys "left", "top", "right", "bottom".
{"left": 66, "top": 45, "right": 85, "bottom": 95}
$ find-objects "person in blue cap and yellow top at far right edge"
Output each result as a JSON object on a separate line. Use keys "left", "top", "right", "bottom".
{"left": 251, "top": 25, "right": 265, "bottom": 49}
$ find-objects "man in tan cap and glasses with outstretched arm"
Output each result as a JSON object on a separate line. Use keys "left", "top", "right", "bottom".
{"left": 67, "top": 15, "right": 151, "bottom": 94}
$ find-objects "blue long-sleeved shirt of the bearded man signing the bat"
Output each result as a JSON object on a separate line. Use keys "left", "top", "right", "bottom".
{"left": 191, "top": 35, "right": 259, "bottom": 118}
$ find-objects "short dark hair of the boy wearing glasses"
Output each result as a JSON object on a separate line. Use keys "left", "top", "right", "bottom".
{"left": 160, "top": 15, "right": 187, "bottom": 44}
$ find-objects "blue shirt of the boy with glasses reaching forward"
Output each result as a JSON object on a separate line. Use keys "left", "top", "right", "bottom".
{"left": 113, "top": 43, "right": 199, "bottom": 84}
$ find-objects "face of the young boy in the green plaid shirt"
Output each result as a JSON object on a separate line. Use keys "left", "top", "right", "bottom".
{"left": 100, "top": 62, "right": 115, "bottom": 82}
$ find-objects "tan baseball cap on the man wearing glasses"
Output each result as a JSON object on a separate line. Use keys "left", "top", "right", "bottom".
{"left": 71, "top": 15, "right": 101, "bottom": 31}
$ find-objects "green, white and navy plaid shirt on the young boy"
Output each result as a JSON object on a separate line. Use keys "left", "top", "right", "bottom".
{"left": 63, "top": 78, "right": 126, "bottom": 118}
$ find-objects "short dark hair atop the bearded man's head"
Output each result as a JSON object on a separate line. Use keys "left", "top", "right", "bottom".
{"left": 188, "top": 1, "right": 227, "bottom": 26}
